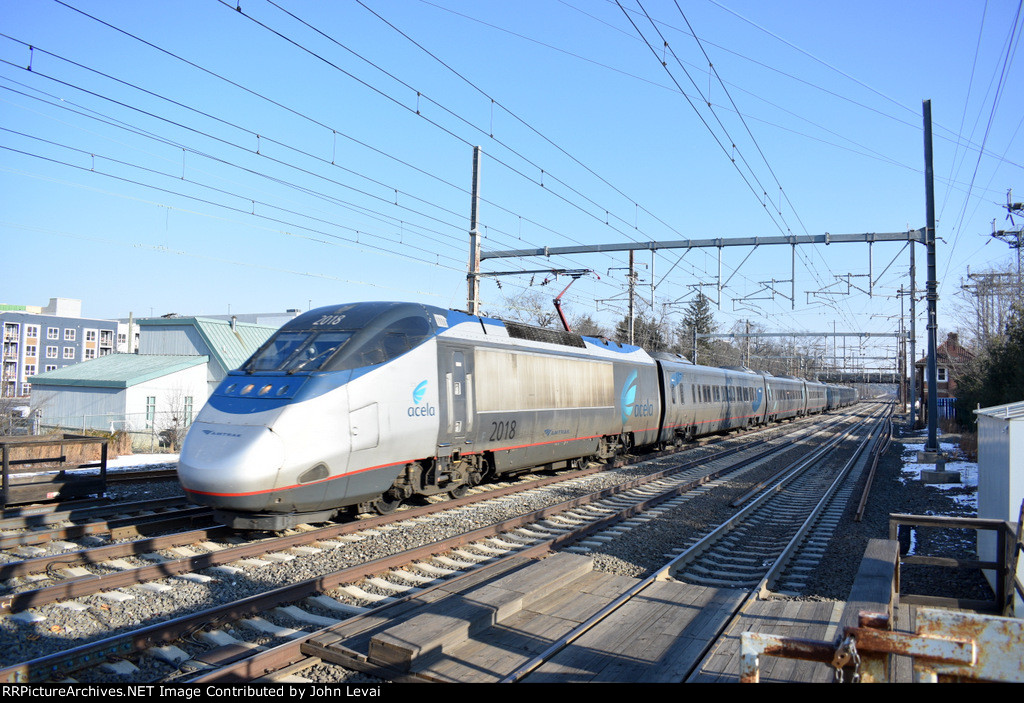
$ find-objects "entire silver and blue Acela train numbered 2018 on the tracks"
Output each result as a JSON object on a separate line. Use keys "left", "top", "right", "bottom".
{"left": 178, "top": 303, "right": 857, "bottom": 530}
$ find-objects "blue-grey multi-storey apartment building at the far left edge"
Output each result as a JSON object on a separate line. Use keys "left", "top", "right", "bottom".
{"left": 0, "top": 298, "right": 128, "bottom": 397}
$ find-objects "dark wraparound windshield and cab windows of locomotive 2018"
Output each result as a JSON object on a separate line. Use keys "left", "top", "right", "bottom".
{"left": 242, "top": 303, "right": 433, "bottom": 374}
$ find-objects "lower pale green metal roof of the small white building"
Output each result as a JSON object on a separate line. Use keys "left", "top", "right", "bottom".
{"left": 29, "top": 354, "right": 210, "bottom": 388}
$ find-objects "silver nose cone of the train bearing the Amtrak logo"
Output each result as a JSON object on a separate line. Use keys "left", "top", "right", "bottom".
{"left": 178, "top": 422, "right": 285, "bottom": 495}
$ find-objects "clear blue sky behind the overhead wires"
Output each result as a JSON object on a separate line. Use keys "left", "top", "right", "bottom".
{"left": 0, "top": 0, "right": 1024, "bottom": 370}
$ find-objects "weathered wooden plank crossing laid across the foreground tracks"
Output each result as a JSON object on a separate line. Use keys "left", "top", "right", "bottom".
{"left": 304, "top": 544, "right": 907, "bottom": 683}
